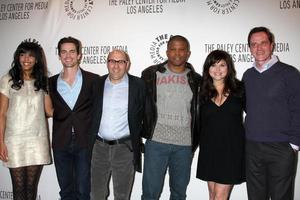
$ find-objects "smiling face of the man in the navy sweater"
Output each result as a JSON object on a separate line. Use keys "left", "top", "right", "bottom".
{"left": 249, "top": 32, "right": 274, "bottom": 67}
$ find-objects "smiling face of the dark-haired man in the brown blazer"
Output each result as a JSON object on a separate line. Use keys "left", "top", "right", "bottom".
{"left": 59, "top": 43, "right": 81, "bottom": 68}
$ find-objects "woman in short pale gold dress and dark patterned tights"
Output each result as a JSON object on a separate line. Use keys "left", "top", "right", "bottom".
{"left": 0, "top": 40, "right": 53, "bottom": 200}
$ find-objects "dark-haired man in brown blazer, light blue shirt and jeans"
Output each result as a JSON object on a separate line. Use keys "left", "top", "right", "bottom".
{"left": 49, "top": 37, "right": 100, "bottom": 200}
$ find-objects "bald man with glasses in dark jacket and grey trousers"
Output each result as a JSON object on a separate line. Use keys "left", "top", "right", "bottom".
{"left": 91, "top": 50, "right": 145, "bottom": 200}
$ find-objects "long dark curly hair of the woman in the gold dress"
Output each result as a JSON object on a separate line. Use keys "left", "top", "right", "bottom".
{"left": 8, "top": 39, "right": 48, "bottom": 92}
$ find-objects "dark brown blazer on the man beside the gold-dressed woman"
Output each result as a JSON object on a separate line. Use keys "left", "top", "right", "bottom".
{"left": 49, "top": 69, "right": 100, "bottom": 150}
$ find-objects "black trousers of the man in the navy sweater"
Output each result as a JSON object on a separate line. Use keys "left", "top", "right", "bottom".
{"left": 246, "top": 141, "right": 298, "bottom": 200}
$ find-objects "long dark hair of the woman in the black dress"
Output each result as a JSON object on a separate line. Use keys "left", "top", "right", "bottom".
{"left": 200, "top": 50, "right": 243, "bottom": 102}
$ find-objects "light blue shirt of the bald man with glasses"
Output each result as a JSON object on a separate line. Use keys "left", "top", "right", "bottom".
{"left": 98, "top": 74, "right": 129, "bottom": 140}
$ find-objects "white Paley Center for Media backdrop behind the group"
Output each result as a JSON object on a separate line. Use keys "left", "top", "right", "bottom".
{"left": 0, "top": 0, "right": 300, "bottom": 200}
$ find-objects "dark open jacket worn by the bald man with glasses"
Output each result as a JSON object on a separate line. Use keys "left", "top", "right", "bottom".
{"left": 92, "top": 74, "right": 146, "bottom": 172}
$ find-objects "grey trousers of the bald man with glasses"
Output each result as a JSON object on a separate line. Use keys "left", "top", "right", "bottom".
{"left": 91, "top": 140, "right": 135, "bottom": 200}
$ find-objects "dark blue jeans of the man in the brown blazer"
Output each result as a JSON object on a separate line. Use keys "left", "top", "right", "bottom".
{"left": 53, "top": 136, "right": 91, "bottom": 200}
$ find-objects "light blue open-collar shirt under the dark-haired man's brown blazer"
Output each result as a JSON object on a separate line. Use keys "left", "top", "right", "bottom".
{"left": 57, "top": 69, "right": 82, "bottom": 110}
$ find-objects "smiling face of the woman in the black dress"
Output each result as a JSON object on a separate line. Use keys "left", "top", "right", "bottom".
{"left": 208, "top": 60, "right": 228, "bottom": 82}
